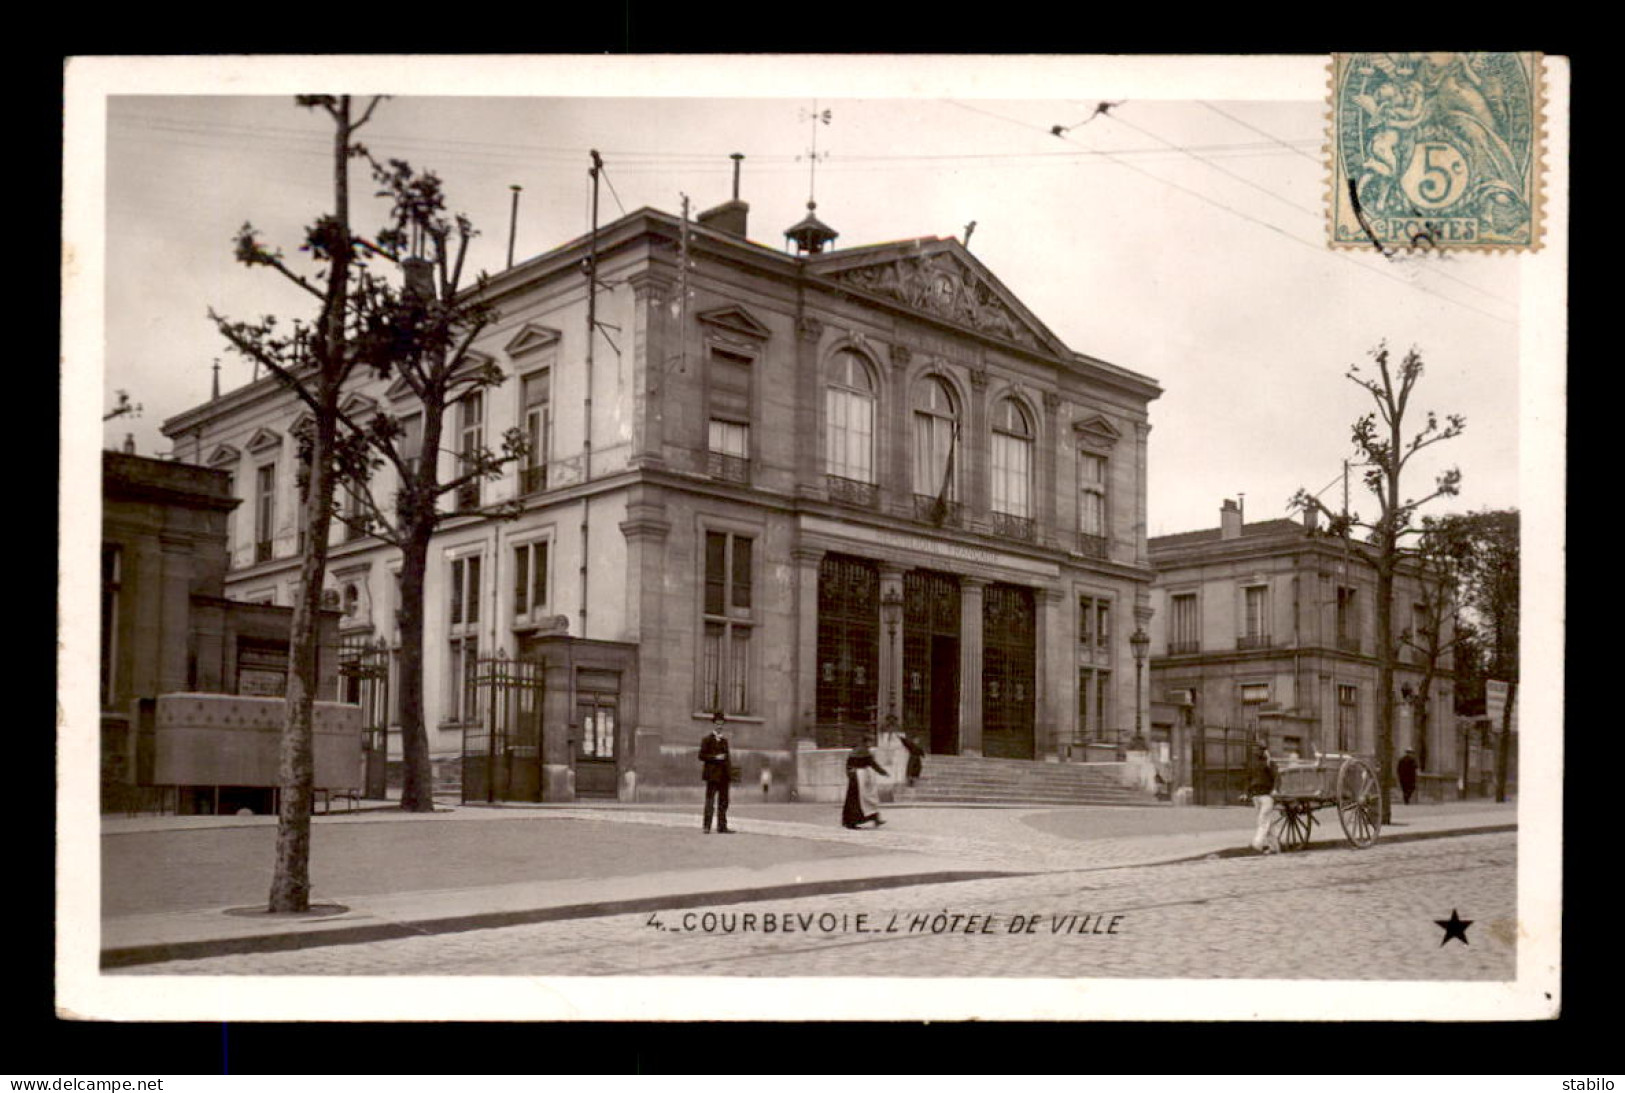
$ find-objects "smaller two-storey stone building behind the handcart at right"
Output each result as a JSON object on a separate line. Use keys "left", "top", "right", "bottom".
{"left": 1151, "top": 500, "right": 1467, "bottom": 804}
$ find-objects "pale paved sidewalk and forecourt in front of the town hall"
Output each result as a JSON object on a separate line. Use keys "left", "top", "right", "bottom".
{"left": 101, "top": 802, "right": 1518, "bottom": 968}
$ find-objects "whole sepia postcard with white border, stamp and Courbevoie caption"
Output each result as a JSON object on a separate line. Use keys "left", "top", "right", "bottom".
{"left": 55, "top": 52, "right": 1570, "bottom": 1022}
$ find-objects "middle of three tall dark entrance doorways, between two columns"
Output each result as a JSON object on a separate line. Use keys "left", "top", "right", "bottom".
{"left": 904, "top": 570, "right": 960, "bottom": 755}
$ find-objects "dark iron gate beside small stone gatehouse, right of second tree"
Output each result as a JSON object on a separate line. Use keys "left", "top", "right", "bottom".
{"left": 463, "top": 655, "right": 546, "bottom": 802}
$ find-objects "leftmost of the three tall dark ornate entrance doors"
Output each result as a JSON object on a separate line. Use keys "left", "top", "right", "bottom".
{"left": 817, "top": 554, "right": 881, "bottom": 747}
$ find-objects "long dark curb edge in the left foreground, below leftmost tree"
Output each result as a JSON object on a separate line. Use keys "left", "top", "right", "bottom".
{"left": 101, "top": 869, "right": 1032, "bottom": 971}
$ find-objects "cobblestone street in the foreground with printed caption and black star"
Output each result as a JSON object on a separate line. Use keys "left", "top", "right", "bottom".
{"left": 119, "top": 833, "right": 1518, "bottom": 981}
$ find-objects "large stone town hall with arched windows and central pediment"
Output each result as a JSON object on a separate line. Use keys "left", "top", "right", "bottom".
{"left": 164, "top": 190, "right": 1157, "bottom": 799}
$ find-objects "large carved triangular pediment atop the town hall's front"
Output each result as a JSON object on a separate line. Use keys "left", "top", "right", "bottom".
{"left": 808, "top": 239, "right": 1069, "bottom": 356}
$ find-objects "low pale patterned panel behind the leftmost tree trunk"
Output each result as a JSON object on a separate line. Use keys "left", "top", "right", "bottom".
{"left": 153, "top": 693, "right": 361, "bottom": 789}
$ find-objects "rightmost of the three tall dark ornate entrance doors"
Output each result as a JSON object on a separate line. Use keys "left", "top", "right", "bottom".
{"left": 982, "top": 585, "right": 1037, "bottom": 758}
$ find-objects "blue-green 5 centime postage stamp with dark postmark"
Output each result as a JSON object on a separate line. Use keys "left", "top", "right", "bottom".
{"left": 1328, "top": 54, "right": 1542, "bottom": 252}
